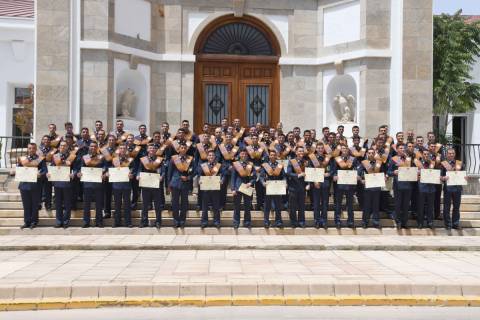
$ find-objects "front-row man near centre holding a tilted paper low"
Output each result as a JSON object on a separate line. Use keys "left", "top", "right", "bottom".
{"left": 232, "top": 149, "right": 257, "bottom": 229}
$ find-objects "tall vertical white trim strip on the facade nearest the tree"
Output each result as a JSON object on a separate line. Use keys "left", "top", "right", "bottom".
{"left": 390, "top": 0, "right": 403, "bottom": 134}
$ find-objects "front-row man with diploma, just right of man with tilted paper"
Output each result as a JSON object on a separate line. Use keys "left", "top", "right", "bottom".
{"left": 260, "top": 150, "right": 285, "bottom": 228}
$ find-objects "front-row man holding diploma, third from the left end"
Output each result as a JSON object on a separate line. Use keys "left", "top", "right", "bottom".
{"left": 74, "top": 141, "right": 105, "bottom": 228}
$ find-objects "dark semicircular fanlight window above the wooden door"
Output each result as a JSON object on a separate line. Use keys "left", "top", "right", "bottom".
{"left": 202, "top": 22, "right": 274, "bottom": 56}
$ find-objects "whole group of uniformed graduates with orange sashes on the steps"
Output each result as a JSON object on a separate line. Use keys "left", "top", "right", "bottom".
{"left": 17, "top": 119, "right": 463, "bottom": 229}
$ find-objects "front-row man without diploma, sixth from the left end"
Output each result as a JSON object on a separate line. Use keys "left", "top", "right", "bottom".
{"left": 168, "top": 143, "right": 193, "bottom": 228}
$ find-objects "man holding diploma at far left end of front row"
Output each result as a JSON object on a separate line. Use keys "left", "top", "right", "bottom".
{"left": 17, "top": 142, "right": 47, "bottom": 229}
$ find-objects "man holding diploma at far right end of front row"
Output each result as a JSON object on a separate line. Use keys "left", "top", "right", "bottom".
{"left": 441, "top": 148, "right": 464, "bottom": 230}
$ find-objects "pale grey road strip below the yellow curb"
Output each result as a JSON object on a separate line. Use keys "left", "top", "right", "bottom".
{"left": 0, "top": 307, "right": 480, "bottom": 320}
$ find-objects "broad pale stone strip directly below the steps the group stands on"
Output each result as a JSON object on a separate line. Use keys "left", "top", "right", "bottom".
{"left": 0, "top": 234, "right": 480, "bottom": 251}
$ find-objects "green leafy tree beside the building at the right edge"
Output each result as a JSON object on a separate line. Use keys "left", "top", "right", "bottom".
{"left": 433, "top": 10, "right": 480, "bottom": 135}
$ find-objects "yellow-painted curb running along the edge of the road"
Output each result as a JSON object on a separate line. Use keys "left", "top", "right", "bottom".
{"left": 0, "top": 295, "right": 480, "bottom": 311}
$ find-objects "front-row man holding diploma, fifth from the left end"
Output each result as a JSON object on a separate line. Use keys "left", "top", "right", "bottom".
{"left": 137, "top": 143, "right": 165, "bottom": 229}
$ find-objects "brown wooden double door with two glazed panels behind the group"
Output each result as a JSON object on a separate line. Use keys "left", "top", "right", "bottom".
{"left": 194, "top": 59, "right": 280, "bottom": 132}
